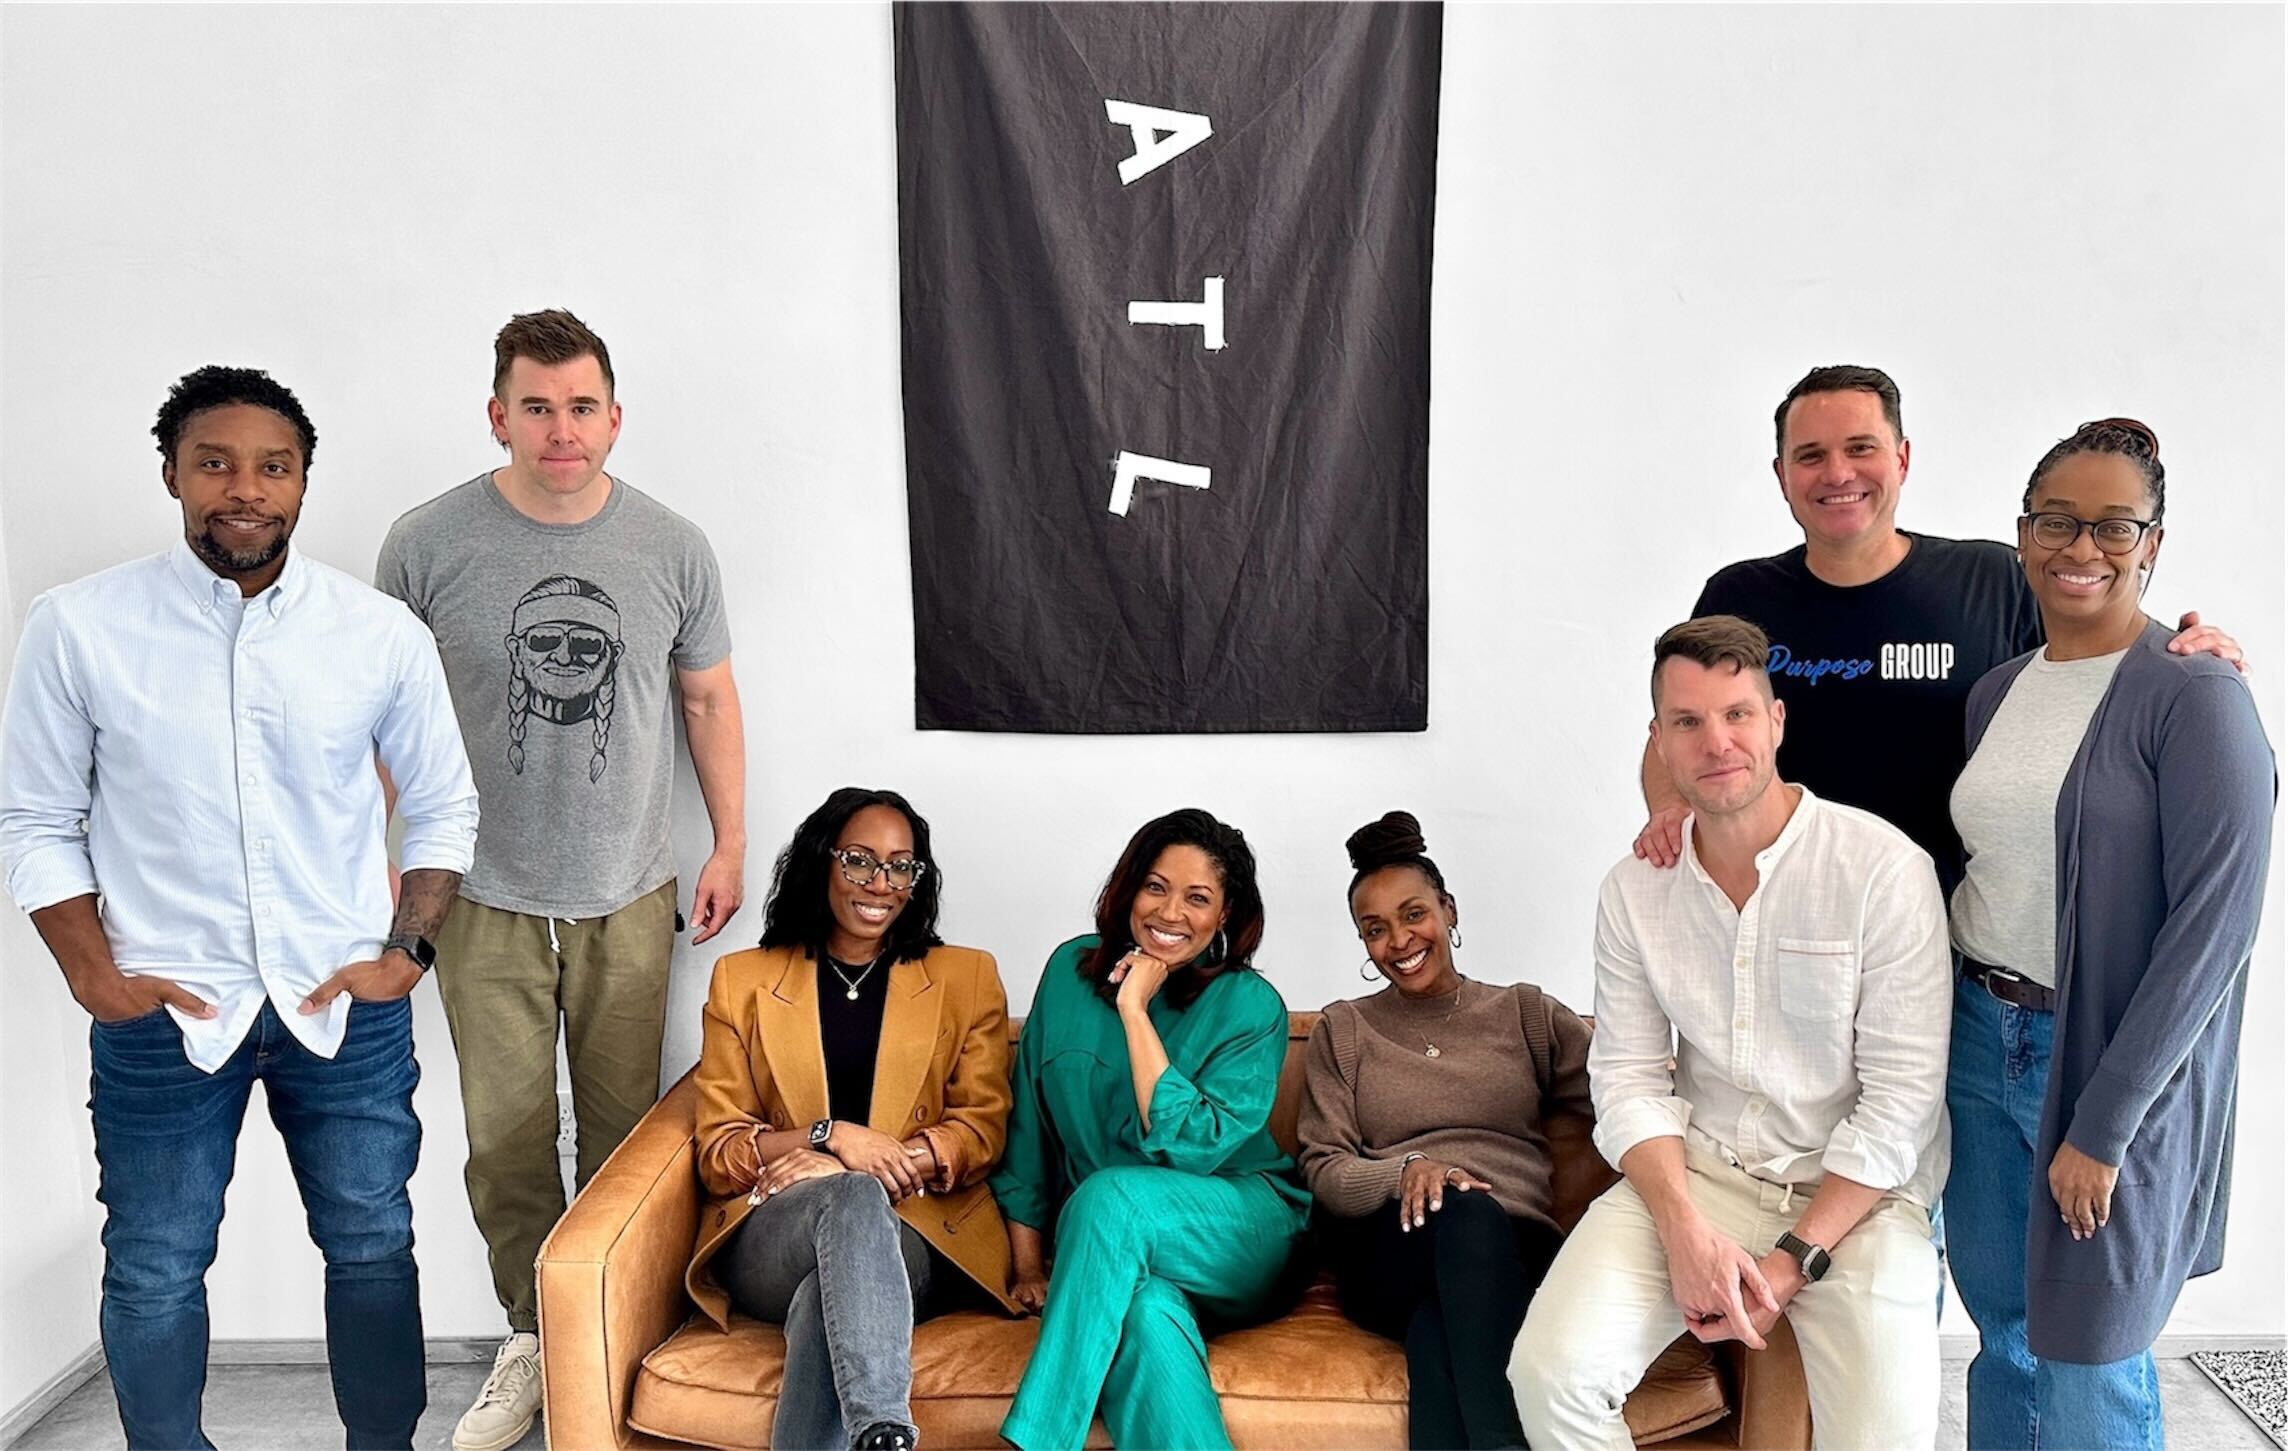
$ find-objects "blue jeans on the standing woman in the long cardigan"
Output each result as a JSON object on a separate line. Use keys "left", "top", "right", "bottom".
{"left": 1945, "top": 982, "right": 2162, "bottom": 1451}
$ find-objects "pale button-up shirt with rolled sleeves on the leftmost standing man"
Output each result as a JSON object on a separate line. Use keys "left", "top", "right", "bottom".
{"left": 0, "top": 542, "right": 476, "bottom": 1073}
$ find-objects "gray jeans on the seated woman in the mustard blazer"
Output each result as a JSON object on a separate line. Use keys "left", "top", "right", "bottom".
{"left": 716, "top": 1174, "right": 929, "bottom": 1451}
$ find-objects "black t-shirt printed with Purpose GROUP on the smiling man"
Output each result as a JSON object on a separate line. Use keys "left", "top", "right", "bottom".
{"left": 1693, "top": 529, "right": 2041, "bottom": 895}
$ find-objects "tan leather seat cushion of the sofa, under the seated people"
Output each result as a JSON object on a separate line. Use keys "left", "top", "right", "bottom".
{"left": 627, "top": 1279, "right": 1725, "bottom": 1451}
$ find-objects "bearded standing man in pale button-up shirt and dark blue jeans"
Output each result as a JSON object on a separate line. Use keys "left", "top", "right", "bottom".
{"left": 0, "top": 366, "right": 476, "bottom": 1449}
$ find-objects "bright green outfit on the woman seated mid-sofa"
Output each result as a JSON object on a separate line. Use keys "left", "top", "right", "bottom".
{"left": 993, "top": 936, "right": 1311, "bottom": 1451}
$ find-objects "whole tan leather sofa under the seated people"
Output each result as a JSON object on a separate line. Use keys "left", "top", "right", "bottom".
{"left": 540, "top": 1014, "right": 1812, "bottom": 1451}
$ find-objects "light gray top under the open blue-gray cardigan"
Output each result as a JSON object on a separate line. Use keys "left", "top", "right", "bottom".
{"left": 1947, "top": 648, "right": 2128, "bottom": 986}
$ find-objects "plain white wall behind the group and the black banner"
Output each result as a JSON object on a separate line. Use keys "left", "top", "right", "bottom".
{"left": 0, "top": 5, "right": 2288, "bottom": 1403}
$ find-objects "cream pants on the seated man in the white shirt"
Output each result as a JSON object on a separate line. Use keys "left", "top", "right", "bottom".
{"left": 1510, "top": 1149, "right": 1938, "bottom": 1451}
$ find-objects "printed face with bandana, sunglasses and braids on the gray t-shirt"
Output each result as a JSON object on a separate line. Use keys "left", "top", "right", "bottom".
{"left": 508, "top": 574, "right": 627, "bottom": 785}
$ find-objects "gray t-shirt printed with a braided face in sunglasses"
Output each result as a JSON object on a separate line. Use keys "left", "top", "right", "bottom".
{"left": 373, "top": 471, "right": 730, "bottom": 918}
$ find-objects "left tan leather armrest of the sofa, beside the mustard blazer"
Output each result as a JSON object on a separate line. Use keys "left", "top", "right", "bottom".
{"left": 538, "top": 1073, "right": 700, "bottom": 1449}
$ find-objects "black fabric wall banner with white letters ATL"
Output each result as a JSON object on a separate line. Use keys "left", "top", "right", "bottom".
{"left": 895, "top": 5, "right": 1441, "bottom": 732}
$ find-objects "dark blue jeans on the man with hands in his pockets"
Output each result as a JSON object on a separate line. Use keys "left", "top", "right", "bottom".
{"left": 87, "top": 1000, "right": 428, "bottom": 1451}
